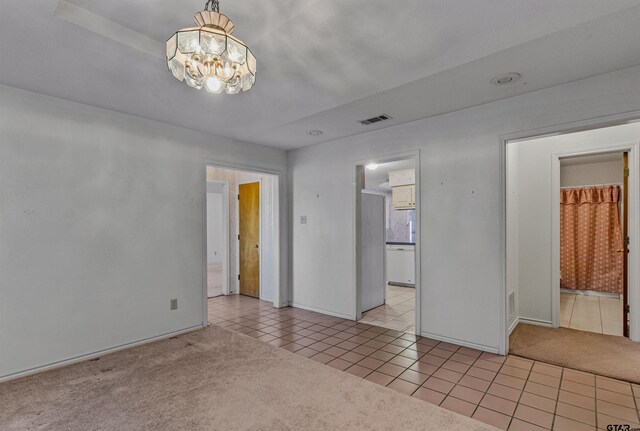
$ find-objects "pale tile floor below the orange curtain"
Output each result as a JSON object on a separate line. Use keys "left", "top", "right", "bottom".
{"left": 560, "top": 293, "right": 622, "bottom": 336}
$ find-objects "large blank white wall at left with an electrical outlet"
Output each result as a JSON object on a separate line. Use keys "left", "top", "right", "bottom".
{"left": 0, "top": 86, "right": 287, "bottom": 378}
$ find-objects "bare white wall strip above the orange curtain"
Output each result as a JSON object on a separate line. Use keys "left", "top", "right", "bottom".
{"left": 560, "top": 158, "right": 624, "bottom": 187}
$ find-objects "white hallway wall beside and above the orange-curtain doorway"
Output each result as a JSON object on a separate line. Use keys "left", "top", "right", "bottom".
{"left": 508, "top": 123, "right": 640, "bottom": 325}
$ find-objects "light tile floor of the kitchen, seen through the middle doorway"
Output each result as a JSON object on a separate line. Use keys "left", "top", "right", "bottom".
{"left": 360, "top": 285, "right": 416, "bottom": 334}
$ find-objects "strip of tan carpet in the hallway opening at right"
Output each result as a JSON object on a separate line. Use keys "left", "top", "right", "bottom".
{"left": 509, "top": 323, "right": 640, "bottom": 383}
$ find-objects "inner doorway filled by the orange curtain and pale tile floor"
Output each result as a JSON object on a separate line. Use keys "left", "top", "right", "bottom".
{"left": 557, "top": 152, "right": 629, "bottom": 337}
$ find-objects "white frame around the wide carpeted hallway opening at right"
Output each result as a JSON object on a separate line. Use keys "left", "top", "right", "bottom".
{"left": 498, "top": 111, "right": 640, "bottom": 355}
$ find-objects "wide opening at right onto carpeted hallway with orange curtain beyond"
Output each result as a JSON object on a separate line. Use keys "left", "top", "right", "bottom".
{"left": 506, "top": 122, "right": 640, "bottom": 378}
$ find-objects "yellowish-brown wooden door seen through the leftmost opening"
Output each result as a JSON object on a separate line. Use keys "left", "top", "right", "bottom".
{"left": 238, "top": 183, "right": 260, "bottom": 298}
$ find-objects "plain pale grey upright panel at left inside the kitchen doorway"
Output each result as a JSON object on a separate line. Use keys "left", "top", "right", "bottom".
{"left": 361, "top": 193, "right": 385, "bottom": 312}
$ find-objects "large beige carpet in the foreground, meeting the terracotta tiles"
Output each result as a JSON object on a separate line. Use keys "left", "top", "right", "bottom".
{"left": 0, "top": 326, "right": 494, "bottom": 431}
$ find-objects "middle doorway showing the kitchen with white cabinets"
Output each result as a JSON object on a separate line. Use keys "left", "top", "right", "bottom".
{"left": 355, "top": 154, "right": 419, "bottom": 334}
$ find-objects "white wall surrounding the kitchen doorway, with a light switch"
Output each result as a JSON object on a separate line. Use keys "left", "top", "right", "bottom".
{"left": 288, "top": 67, "right": 640, "bottom": 353}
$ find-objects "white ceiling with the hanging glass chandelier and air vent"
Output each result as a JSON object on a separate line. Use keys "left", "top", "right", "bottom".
{"left": 0, "top": 0, "right": 640, "bottom": 148}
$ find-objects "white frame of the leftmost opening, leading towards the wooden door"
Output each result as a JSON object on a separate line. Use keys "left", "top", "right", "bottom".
{"left": 200, "top": 158, "right": 282, "bottom": 327}
